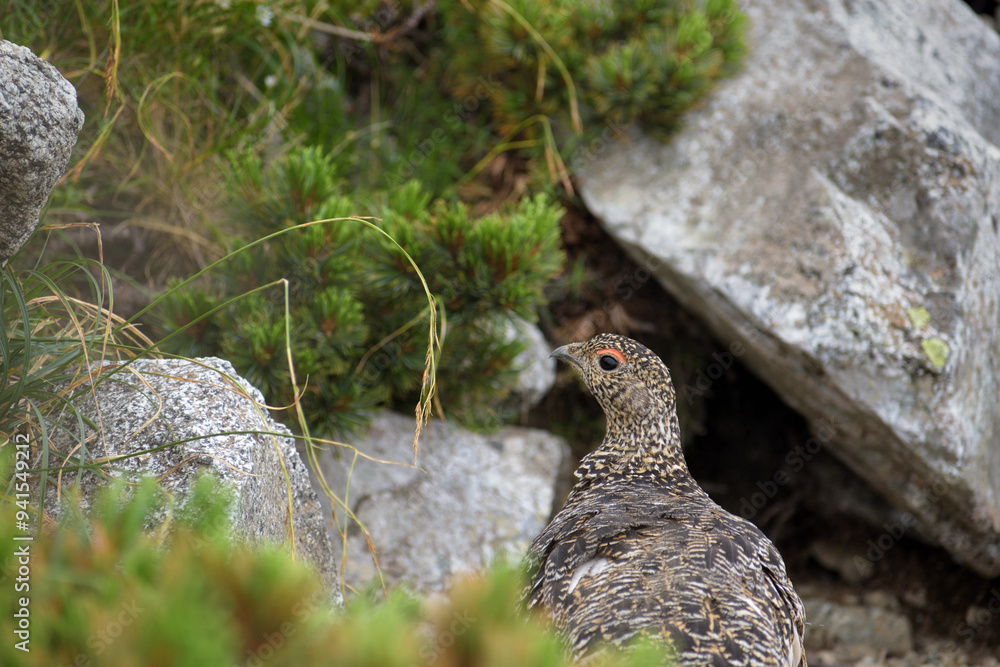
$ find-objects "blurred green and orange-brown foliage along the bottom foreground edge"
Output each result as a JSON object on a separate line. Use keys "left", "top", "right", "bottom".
{"left": 0, "top": 470, "right": 672, "bottom": 667}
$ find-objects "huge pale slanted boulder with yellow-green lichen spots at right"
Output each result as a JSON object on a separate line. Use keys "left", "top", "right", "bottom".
{"left": 580, "top": 0, "right": 1000, "bottom": 576}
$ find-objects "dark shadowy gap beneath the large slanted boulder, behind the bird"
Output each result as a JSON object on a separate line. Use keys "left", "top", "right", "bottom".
{"left": 528, "top": 204, "right": 1000, "bottom": 657}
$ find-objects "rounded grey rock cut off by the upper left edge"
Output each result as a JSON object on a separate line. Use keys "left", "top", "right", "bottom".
{"left": 0, "top": 40, "right": 83, "bottom": 261}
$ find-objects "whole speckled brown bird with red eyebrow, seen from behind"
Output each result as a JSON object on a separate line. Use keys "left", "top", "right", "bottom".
{"left": 528, "top": 334, "right": 806, "bottom": 667}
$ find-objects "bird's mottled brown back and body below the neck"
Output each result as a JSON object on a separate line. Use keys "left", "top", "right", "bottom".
{"left": 529, "top": 479, "right": 804, "bottom": 667}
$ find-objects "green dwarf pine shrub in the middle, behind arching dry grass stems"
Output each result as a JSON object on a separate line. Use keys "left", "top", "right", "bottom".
{"left": 156, "top": 148, "right": 563, "bottom": 434}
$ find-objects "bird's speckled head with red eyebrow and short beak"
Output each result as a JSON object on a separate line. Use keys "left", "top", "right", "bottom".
{"left": 551, "top": 334, "right": 679, "bottom": 435}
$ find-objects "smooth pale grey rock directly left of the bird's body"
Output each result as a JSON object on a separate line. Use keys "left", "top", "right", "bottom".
{"left": 319, "top": 413, "right": 568, "bottom": 592}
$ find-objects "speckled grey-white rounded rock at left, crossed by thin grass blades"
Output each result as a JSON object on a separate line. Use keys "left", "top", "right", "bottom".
{"left": 36, "top": 358, "right": 341, "bottom": 602}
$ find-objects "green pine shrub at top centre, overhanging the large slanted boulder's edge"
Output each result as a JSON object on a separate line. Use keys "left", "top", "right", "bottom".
{"left": 440, "top": 0, "right": 745, "bottom": 138}
